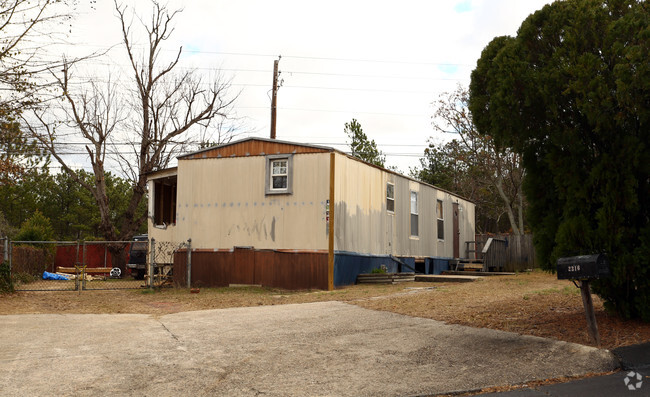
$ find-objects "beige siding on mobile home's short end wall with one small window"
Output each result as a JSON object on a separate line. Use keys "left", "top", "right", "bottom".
{"left": 165, "top": 153, "right": 329, "bottom": 250}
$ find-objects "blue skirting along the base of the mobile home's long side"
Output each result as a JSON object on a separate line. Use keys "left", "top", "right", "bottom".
{"left": 334, "top": 252, "right": 449, "bottom": 287}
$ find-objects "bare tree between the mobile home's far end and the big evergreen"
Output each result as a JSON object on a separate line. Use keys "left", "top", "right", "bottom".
{"left": 433, "top": 86, "right": 525, "bottom": 235}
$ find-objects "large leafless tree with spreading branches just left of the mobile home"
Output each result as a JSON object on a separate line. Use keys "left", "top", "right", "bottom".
{"left": 30, "top": 1, "right": 235, "bottom": 264}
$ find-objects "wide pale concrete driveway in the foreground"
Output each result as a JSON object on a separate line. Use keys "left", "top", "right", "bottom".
{"left": 0, "top": 302, "right": 618, "bottom": 397}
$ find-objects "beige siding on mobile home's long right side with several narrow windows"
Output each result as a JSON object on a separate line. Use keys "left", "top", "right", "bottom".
{"left": 335, "top": 154, "right": 474, "bottom": 257}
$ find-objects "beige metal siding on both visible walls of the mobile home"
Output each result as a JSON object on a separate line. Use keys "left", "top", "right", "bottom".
{"left": 149, "top": 148, "right": 474, "bottom": 257}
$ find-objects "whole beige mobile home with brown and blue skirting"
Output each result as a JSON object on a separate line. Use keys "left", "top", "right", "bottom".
{"left": 148, "top": 138, "right": 475, "bottom": 289}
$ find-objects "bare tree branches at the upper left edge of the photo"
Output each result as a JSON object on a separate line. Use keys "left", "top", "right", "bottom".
{"left": 0, "top": 0, "right": 73, "bottom": 184}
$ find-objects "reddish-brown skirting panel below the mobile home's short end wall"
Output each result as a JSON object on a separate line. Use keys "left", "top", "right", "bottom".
{"left": 174, "top": 247, "right": 327, "bottom": 290}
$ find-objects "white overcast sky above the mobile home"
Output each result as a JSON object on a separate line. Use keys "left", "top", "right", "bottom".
{"left": 60, "top": 0, "right": 549, "bottom": 173}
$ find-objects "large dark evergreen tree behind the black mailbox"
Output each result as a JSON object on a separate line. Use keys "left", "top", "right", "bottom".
{"left": 469, "top": 0, "right": 650, "bottom": 321}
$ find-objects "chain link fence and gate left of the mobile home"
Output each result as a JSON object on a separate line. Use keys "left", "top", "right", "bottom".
{"left": 0, "top": 236, "right": 191, "bottom": 291}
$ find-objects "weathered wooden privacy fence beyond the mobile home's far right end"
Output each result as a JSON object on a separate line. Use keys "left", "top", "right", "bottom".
{"left": 476, "top": 234, "right": 537, "bottom": 272}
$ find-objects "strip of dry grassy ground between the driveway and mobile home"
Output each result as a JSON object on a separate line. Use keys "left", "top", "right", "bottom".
{"left": 0, "top": 272, "right": 650, "bottom": 349}
